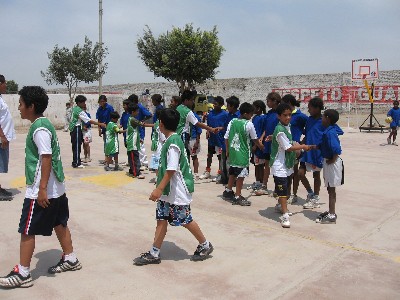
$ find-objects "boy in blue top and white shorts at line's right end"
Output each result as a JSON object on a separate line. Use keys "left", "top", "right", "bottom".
{"left": 315, "top": 109, "right": 344, "bottom": 224}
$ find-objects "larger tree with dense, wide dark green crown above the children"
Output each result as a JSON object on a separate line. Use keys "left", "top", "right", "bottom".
{"left": 137, "top": 24, "right": 225, "bottom": 92}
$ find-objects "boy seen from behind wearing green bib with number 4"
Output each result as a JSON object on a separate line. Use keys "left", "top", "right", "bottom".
{"left": 222, "top": 102, "right": 264, "bottom": 206}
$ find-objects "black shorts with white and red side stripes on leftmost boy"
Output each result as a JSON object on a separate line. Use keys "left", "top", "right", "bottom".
{"left": 18, "top": 194, "right": 69, "bottom": 236}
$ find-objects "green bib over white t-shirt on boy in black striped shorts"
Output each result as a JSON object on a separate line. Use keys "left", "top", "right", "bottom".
{"left": 25, "top": 117, "right": 65, "bottom": 199}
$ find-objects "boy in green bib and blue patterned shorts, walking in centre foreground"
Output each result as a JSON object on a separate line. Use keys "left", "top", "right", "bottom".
{"left": 133, "top": 108, "right": 214, "bottom": 266}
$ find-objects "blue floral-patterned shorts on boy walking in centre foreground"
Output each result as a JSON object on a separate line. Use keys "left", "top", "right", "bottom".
{"left": 156, "top": 201, "right": 193, "bottom": 226}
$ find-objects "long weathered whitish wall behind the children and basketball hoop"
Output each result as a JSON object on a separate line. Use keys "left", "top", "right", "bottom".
{"left": 3, "top": 70, "right": 400, "bottom": 127}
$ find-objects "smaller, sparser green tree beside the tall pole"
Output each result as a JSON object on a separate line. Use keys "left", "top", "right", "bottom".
{"left": 40, "top": 37, "right": 108, "bottom": 101}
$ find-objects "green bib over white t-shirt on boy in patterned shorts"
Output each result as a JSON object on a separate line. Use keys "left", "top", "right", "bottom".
{"left": 157, "top": 133, "right": 194, "bottom": 205}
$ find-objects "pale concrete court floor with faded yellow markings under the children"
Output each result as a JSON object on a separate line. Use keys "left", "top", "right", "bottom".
{"left": 0, "top": 129, "right": 400, "bottom": 299}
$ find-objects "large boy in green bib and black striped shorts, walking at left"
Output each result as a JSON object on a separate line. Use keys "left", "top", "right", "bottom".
{"left": 0, "top": 86, "right": 82, "bottom": 288}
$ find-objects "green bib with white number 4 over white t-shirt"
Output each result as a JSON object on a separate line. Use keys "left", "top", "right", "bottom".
{"left": 225, "top": 119, "right": 257, "bottom": 168}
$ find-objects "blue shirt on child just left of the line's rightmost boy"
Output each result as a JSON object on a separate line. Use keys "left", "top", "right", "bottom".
{"left": 301, "top": 116, "right": 325, "bottom": 168}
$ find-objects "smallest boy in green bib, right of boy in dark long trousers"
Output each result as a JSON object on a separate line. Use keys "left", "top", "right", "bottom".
{"left": 104, "top": 111, "right": 126, "bottom": 171}
